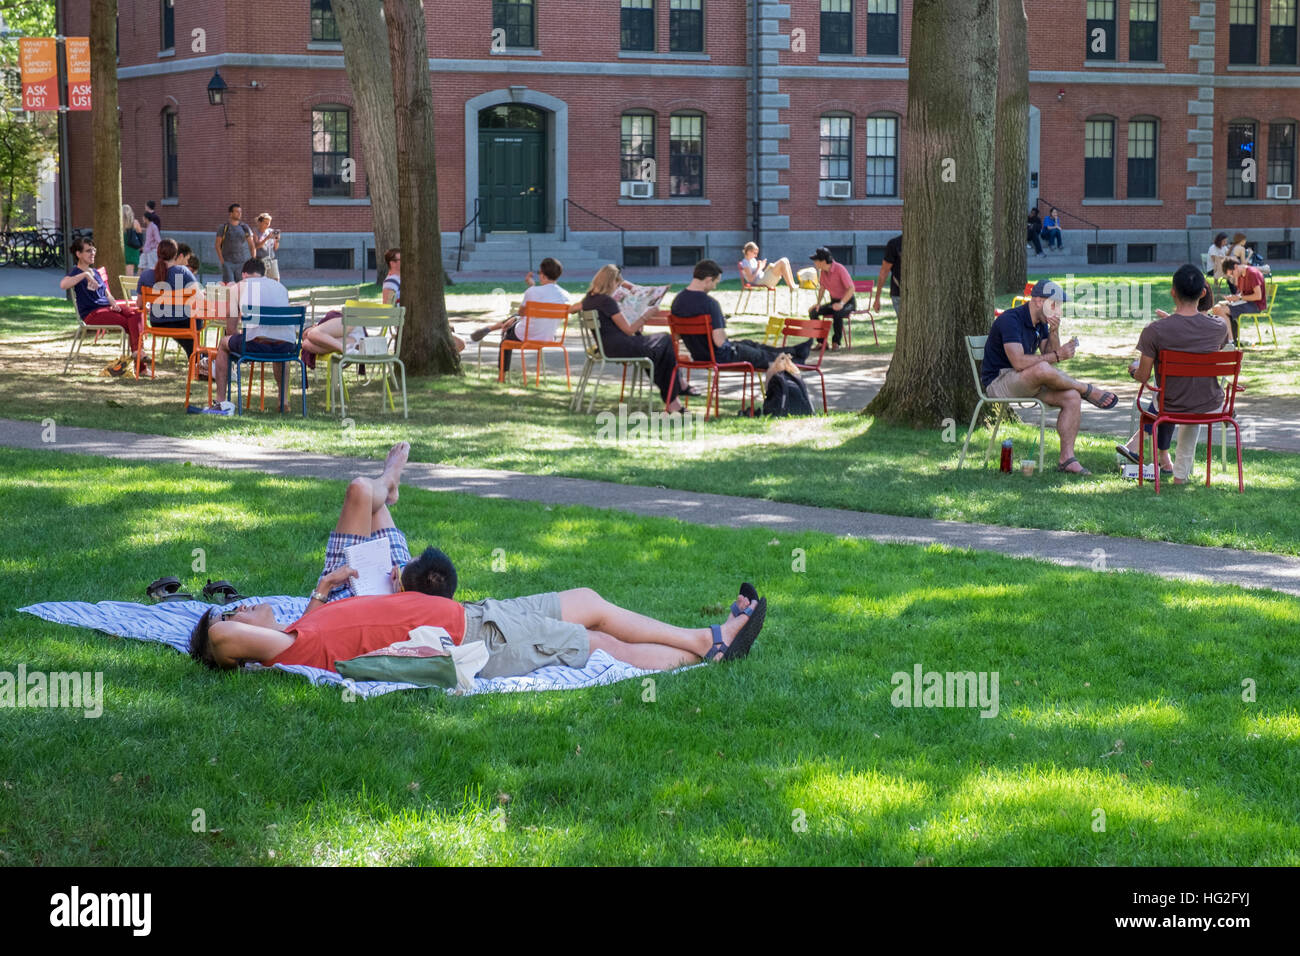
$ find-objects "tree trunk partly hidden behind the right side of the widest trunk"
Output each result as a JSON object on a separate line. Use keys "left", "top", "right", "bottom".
{"left": 993, "top": 0, "right": 1030, "bottom": 293}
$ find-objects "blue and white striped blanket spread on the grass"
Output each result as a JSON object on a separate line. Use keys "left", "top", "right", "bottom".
{"left": 18, "top": 594, "right": 655, "bottom": 697}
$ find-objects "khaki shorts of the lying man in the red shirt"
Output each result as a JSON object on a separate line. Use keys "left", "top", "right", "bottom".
{"left": 462, "top": 591, "right": 592, "bottom": 678}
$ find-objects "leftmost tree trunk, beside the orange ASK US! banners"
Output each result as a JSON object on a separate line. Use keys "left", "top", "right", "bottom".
{"left": 90, "top": 0, "right": 126, "bottom": 293}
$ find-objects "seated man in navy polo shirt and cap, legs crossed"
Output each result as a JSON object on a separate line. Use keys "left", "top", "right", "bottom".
{"left": 980, "top": 278, "right": 1119, "bottom": 475}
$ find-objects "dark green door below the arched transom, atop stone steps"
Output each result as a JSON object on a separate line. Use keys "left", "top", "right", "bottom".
{"left": 478, "top": 129, "right": 546, "bottom": 233}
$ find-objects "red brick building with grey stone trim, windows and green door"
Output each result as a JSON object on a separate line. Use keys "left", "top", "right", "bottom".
{"left": 68, "top": 0, "right": 1300, "bottom": 273}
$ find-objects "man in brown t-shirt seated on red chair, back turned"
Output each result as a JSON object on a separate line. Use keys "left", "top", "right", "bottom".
{"left": 1115, "top": 264, "right": 1229, "bottom": 485}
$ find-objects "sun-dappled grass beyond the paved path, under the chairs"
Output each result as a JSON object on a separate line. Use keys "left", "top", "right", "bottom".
{"left": 0, "top": 276, "right": 1300, "bottom": 554}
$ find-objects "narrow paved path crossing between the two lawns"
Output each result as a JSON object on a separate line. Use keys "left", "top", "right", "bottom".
{"left": 0, "top": 419, "right": 1300, "bottom": 594}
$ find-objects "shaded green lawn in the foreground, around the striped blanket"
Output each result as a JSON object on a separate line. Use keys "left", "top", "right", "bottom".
{"left": 0, "top": 451, "right": 1300, "bottom": 866}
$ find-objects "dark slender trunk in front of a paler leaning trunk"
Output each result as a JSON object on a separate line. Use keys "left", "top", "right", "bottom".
{"left": 384, "top": 0, "right": 460, "bottom": 375}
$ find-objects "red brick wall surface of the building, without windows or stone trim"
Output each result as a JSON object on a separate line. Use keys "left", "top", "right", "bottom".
{"left": 68, "top": 0, "right": 1300, "bottom": 243}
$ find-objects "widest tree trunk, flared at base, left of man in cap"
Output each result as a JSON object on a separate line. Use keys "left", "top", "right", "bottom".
{"left": 866, "top": 0, "right": 998, "bottom": 428}
